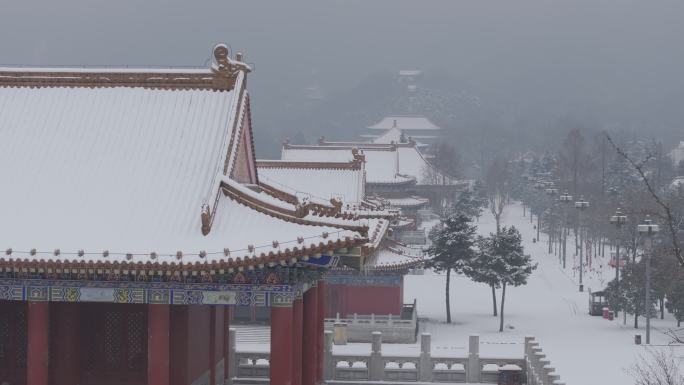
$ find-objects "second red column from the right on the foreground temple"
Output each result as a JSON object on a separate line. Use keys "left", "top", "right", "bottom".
{"left": 302, "top": 286, "right": 318, "bottom": 385}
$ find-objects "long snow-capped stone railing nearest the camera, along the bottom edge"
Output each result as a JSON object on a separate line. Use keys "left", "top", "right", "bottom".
{"left": 229, "top": 329, "right": 564, "bottom": 385}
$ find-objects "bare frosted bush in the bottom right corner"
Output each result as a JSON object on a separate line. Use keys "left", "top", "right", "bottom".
{"left": 628, "top": 349, "right": 684, "bottom": 385}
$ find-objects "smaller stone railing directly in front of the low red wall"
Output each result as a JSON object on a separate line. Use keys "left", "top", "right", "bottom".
{"left": 325, "top": 302, "right": 418, "bottom": 343}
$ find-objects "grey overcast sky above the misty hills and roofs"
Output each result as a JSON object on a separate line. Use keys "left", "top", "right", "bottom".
{"left": 0, "top": 0, "right": 684, "bottom": 144}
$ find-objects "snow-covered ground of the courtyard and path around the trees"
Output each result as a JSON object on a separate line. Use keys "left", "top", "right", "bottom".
{"left": 404, "top": 205, "right": 684, "bottom": 385}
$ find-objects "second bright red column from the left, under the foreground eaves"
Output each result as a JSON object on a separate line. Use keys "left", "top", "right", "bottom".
{"left": 147, "top": 305, "right": 171, "bottom": 385}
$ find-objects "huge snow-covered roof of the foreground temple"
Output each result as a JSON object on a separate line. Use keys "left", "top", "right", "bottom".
{"left": 0, "top": 46, "right": 368, "bottom": 263}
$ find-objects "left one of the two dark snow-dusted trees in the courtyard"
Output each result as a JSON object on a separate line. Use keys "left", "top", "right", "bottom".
{"left": 426, "top": 213, "right": 476, "bottom": 323}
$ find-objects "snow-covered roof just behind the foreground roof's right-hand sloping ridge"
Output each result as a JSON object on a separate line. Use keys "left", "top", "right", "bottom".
{"left": 257, "top": 160, "right": 365, "bottom": 203}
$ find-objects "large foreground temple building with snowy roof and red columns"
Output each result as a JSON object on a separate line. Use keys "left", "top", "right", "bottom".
{"left": 0, "top": 45, "right": 380, "bottom": 385}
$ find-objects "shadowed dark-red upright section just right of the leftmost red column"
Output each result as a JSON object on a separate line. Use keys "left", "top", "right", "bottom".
{"left": 50, "top": 302, "right": 81, "bottom": 385}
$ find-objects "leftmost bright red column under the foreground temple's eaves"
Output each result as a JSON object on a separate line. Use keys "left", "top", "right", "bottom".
{"left": 26, "top": 301, "right": 50, "bottom": 385}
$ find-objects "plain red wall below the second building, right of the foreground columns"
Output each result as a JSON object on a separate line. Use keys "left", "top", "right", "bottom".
{"left": 325, "top": 283, "right": 404, "bottom": 318}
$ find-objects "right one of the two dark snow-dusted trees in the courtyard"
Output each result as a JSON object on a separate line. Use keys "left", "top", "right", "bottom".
{"left": 465, "top": 226, "right": 537, "bottom": 332}
